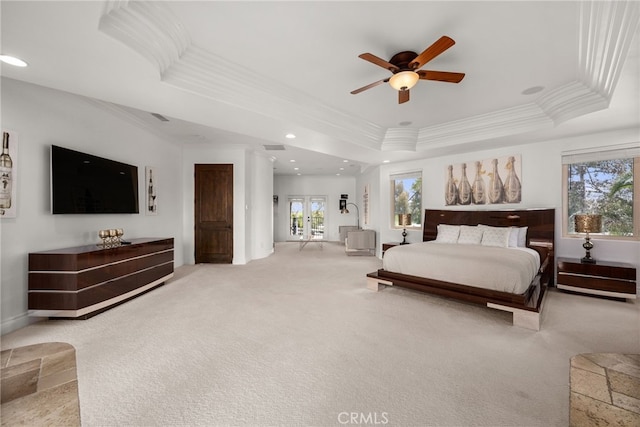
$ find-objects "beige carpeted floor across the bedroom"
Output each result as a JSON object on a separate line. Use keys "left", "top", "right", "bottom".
{"left": 2, "top": 243, "right": 640, "bottom": 426}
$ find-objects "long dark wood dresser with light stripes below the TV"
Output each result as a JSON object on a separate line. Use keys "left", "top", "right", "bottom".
{"left": 29, "top": 238, "right": 173, "bottom": 319}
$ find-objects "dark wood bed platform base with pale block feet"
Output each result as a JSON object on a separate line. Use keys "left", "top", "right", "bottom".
{"left": 367, "top": 271, "right": 546, "bottom": 331}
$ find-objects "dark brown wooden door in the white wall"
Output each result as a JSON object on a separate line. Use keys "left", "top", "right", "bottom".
{"left": 194, "top": 164, "right": 233, "bottom": 264}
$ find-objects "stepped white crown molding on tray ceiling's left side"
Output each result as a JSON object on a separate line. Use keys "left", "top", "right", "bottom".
{"left": 99, "top": 0, "right": 385, "bottom": 149}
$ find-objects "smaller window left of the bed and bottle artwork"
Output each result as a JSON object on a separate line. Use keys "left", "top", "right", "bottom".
{"left": 390, "top": 172, "right": 422, "bottom": 228}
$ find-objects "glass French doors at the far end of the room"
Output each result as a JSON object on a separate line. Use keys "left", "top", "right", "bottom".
{"left": 289, "top": 196, "right": 327, "bottom": 240}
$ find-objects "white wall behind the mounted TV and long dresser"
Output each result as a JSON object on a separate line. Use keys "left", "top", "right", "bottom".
{"left": 0, "top": 78, "right": 183, "bottom": 333}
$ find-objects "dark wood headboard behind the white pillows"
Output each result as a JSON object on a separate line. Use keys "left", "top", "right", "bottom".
{"left": 422, "top": 209, "right": 556, "bottom": 254}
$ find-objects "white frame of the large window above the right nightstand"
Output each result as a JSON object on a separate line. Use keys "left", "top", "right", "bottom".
{"left": 562, "top": 150, "right": 640, "bottom": 241}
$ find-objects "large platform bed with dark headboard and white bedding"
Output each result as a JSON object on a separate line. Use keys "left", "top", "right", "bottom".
{"left": 367, "top": 209, "right": 555, "bottom": 330}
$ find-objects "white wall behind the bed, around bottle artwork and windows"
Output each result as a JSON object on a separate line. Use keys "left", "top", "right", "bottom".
{"left": 358, "top": 129, "right": 640, "bottom": 279}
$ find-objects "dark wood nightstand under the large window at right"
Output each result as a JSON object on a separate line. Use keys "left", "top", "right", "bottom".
{"left": 556, "top": 258, "right": 636, "bottom": 299}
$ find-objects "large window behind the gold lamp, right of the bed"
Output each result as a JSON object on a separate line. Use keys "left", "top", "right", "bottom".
{"left": 562, "top": 148, "right": 640, "bottom": 240}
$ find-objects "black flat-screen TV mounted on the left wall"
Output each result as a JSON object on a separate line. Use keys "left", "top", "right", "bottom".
{"left": 51, "top": 145, "right": 139, "bottom": 214}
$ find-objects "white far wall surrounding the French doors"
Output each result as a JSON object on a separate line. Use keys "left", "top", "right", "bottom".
{"left": 273, "top": 175, "right": 364, "bottom": 242}
